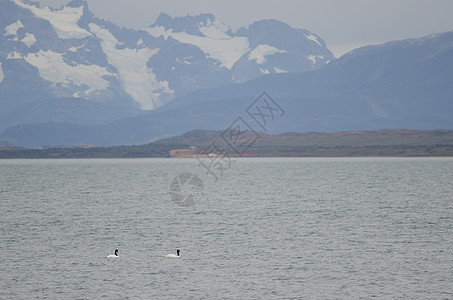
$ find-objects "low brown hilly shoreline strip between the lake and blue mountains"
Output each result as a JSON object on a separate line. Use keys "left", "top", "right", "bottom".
{"left": 0, "top": 130, "right": 453, "bottom": 158}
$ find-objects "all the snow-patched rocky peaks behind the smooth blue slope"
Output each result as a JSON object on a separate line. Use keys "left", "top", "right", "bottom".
{"left": 0, "top": 0, "right": 334, "bottom": 117}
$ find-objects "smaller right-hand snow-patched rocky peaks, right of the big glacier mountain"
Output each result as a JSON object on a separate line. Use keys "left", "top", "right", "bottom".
{"left": 145, "top": 14, "right": 333, "bottom": 83}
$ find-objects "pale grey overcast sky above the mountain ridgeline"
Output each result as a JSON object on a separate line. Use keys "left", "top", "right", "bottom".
{"left": 39, "top": 0, "right": 453, "bottom": 57}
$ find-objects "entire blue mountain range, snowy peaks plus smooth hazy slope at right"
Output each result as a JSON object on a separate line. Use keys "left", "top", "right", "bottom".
{"left": 0, "top": 0, "right": 453, "bottom": 147}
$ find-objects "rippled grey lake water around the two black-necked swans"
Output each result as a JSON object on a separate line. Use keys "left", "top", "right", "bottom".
{"left": 0, "top": 158, "right": 453, "bottom": 299}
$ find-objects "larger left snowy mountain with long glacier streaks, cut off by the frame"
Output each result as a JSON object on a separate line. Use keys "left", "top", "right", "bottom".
{"left": 0, "top": 0, "right": 174, "bottom": 110}
